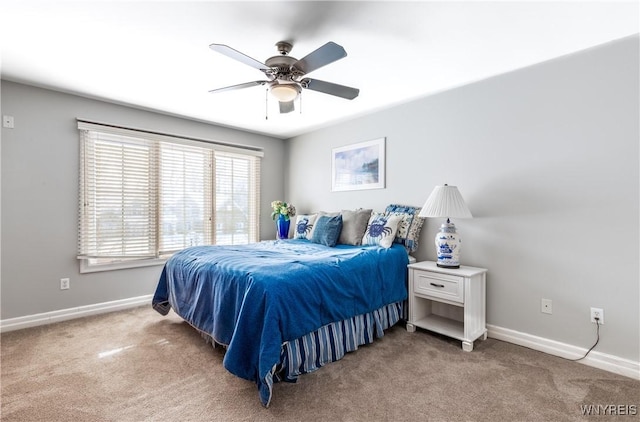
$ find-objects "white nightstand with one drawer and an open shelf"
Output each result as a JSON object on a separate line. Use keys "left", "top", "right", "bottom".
{"left": 407, "top": 261, "right": 487, "bottom": 352}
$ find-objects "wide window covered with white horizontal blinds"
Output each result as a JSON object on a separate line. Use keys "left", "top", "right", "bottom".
{"left": 78, "top": 121, "right": 262, "bottom": 272}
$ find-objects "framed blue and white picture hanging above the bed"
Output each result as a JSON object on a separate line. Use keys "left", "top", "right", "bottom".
{"left": 331, "top": 138, "right": 385, "bottom": 192}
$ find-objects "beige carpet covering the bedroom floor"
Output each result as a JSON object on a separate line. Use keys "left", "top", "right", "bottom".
{"left": 1, "top": 307, "right": 640, "bottom": 422}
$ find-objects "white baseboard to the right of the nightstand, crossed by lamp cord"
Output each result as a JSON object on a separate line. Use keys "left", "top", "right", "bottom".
{"left": 487, "top": 325, "right": 640, "bottom": 380}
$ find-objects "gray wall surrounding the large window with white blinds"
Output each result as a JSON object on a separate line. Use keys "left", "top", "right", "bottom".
{"left": 0, "top": 81, "right": 285, "bottom": 320}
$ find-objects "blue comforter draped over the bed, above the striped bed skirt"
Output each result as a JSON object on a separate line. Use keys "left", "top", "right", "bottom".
{"left": 153, "top": 240, "right": 408, "bottom": 406}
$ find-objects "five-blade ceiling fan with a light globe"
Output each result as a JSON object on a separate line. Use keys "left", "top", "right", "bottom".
{"left": 209, "top": 41, "right": 360, "bottom": 113}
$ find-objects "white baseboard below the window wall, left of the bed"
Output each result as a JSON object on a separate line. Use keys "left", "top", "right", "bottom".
{"left": 0, "top": 295, "right": 153, "bottom": 333}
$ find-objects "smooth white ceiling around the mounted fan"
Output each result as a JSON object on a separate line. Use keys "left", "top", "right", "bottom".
{"left": 0, "top": 0, "right": 639, "bottom": 138}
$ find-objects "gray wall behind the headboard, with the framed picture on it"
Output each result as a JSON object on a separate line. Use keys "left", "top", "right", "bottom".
{"left": 286, "top": 36, "right": 640, "bottom": 362}
